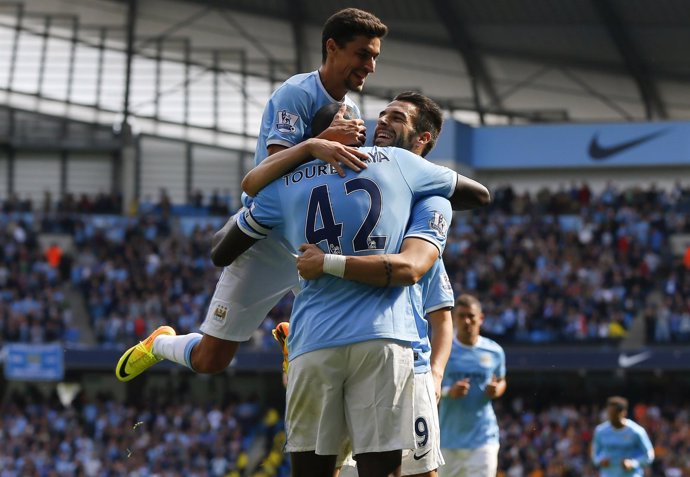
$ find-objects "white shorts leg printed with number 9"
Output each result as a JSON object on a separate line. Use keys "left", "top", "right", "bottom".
{"left": 402, "top": 372, "right": 444, "bottom": 477}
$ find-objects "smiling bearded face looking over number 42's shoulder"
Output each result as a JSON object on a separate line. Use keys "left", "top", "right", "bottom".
{"left": 374, "top": 101, "right": 418, "bottom": 154}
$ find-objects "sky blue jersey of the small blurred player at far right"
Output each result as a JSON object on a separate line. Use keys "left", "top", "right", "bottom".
{"left": 592, "top": 419, "right": 654, "bottom": 477}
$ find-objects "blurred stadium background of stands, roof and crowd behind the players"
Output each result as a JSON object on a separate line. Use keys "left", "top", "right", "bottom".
{"left": 0, "top": 0, "right": 690, "bottom": 477}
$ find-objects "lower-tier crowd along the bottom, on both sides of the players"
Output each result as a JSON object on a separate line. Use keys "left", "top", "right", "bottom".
{"left": 0, "top": 386, "right": 690, "bottom": 477}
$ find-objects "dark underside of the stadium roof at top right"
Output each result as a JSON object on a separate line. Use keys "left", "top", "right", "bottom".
{"left": 196, "top": 0, "right": 690, "bottom": 119}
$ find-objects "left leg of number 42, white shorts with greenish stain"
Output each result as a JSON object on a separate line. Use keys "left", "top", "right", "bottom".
{"left": 285, "top": 347, "right": 346, "bottom": 477}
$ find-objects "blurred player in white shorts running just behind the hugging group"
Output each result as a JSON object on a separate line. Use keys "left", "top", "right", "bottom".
{"left": 439, "top": 295, "right": 506, "bottom": 477}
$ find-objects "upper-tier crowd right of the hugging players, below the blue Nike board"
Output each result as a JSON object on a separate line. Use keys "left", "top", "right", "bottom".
{"left": 444, "top": 184, "right": 690, "bottom": 343}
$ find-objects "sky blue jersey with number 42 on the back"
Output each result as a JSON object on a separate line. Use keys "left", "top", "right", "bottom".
{"left": 238, "top": 147, "right": 457, "bottom": 359}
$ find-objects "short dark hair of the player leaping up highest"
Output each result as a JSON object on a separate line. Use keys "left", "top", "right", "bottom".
{"left": 321, "top": 8, "right": 388, "bottom": 61}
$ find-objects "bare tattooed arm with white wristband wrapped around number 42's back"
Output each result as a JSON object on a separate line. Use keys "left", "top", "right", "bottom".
{"left": 297, "top": 237, "right": 438, "bottom": 287}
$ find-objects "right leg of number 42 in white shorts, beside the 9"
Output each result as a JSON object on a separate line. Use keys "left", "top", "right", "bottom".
{"left": 344, "top": 340, "right": 415, "bottom": 477}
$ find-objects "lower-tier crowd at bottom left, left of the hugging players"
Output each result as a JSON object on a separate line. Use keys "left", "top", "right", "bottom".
{"left": 0, "top": 386, "right": 284, "bottom": 477}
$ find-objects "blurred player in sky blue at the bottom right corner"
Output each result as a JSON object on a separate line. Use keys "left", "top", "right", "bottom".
{"left": 592, "top": 396, "right": 654, "bottom": 477}
